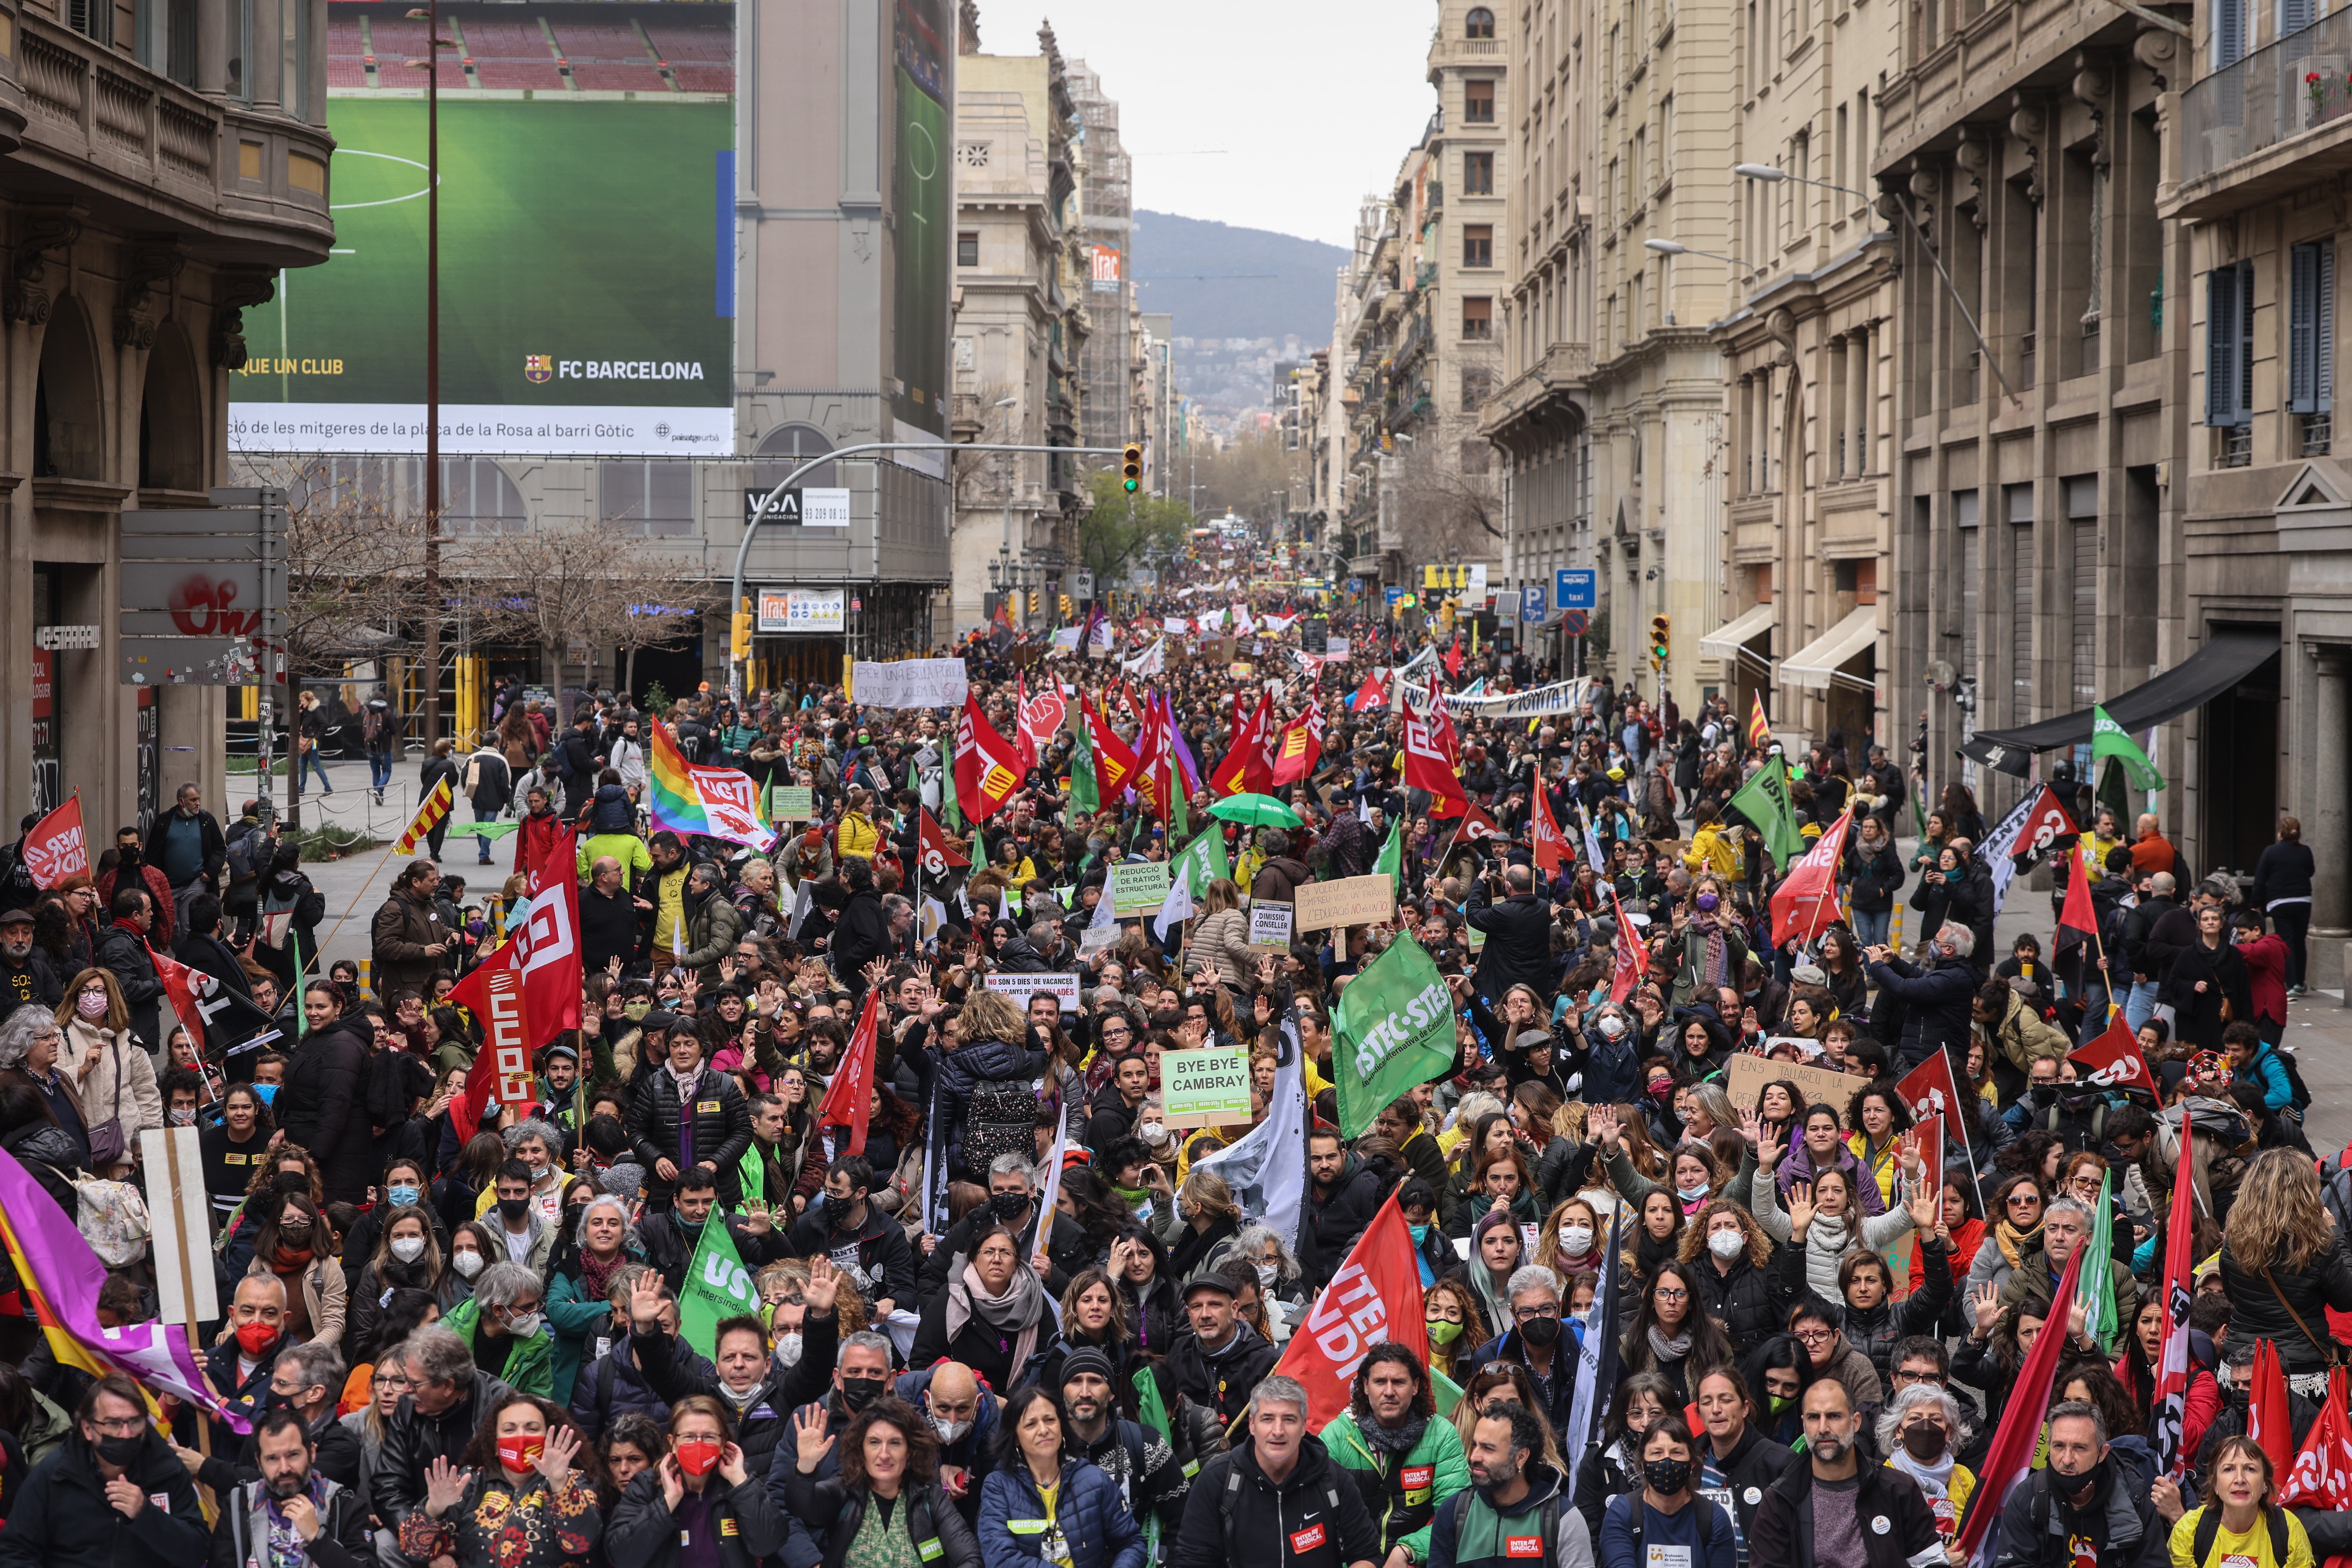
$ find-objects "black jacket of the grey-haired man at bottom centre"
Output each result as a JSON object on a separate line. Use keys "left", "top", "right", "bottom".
{"left": 1169, "top": 1436, "right": 1383, "bottom": 1568}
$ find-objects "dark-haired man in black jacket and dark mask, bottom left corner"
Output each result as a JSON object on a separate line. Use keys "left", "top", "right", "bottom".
{"left": 0, "top": 1375, "right": 207, "bottom": 1568}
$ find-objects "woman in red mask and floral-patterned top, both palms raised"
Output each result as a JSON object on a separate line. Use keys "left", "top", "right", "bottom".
{"left": 400, "top": 1394, "right": 607, "bottom": 1568}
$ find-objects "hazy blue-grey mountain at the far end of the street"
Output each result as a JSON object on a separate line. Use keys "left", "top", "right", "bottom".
{"left": 1134, "top": 211, "right": 1347, "bottom": 346}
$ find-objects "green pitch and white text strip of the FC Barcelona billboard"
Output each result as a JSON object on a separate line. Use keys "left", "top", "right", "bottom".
{"left": 231, "top": 89, "right": 734, "bottom": 456}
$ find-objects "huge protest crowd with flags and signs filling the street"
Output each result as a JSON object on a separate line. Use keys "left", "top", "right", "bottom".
{"left": 0, "top": 526, "right": 2352, "bottom": 1568}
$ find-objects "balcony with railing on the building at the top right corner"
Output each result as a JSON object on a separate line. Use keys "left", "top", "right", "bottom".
{"left": 2164, "top": 10, "right": 2352, "bottom": 219}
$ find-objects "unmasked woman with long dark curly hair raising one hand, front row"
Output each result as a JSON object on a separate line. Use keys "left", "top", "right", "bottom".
{"left": 786, "top": 1396, "right": 981, "bottom": 1568}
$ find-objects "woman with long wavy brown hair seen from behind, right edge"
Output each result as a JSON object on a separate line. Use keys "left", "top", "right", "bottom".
{"left": 2220, "top": 1150, "right": 2352, "bottom": 1399}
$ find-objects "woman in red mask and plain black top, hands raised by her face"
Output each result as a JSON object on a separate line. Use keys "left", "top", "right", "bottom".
{"left": 604, "top": 1394, "right": 788, "bottom": 1568}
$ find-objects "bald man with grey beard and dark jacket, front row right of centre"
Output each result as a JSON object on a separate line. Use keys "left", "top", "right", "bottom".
{"left": 1748, "top": 1378, "right": 1938, "bottom": 1568}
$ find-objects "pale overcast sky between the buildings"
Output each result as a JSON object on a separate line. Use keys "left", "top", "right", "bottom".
{"left": 981, "top": 0, "right": 1437, "bottom": 244}
